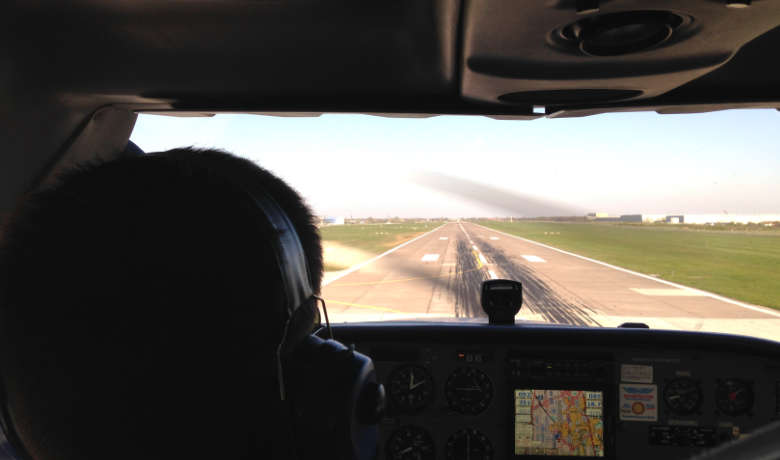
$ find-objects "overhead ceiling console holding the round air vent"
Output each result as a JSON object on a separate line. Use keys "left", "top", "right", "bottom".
{"left": 461, "top": 0, "right": 780, "bottom": 113}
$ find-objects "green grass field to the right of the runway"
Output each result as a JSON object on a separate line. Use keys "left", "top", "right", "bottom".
{"left": 479, "top": 220, "right": 780, "bottom": 309}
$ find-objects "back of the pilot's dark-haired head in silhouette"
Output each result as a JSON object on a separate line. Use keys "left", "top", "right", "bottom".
{"left": 0, "top": 149, "right": 322, "bottom": 459}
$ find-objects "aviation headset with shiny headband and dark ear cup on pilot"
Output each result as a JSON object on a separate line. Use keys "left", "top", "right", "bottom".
{"left": 0, "top": 152, "right": 385, "bottom": 460}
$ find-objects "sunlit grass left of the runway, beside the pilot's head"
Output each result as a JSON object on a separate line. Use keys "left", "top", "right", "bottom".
{"left": 320, "top": 222, "right": 442, "bottom": 271}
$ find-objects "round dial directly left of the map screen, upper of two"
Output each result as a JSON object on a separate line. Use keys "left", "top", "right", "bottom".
{"left": 445, "top": 367, "right": 493, "bottom": 414}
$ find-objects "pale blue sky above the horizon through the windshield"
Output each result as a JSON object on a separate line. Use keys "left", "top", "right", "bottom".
{"left": 131, "top": 110, "right": 780, "bottom": 217}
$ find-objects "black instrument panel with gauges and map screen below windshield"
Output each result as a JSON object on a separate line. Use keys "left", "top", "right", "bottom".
{"left": 334, "top": 323, "right": 780, "bottom": 460}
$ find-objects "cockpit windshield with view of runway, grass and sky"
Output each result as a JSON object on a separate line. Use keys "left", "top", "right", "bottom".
{"left": 131, "top": 110, "right": 780, "bottom": 342}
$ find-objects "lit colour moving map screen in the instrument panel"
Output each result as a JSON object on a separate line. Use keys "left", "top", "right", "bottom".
{"left": 515, "top": 389, "right": 604, "bottom": 457}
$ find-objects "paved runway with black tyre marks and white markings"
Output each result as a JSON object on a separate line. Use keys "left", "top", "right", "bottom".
{"left": 322, "top": 222, "right": 780, "bottom": 340}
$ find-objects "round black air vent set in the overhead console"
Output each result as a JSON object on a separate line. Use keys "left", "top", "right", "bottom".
{"left": 554, "top": 11, "right": 691, "bottom": 56}
